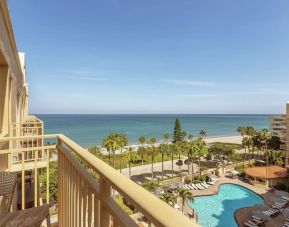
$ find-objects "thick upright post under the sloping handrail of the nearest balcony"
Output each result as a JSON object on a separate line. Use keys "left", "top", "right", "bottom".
{"left": 99, "top": 176, "right": 111, "bottom": 227}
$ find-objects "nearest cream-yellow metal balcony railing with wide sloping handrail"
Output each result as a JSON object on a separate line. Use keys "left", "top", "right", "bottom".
{"left": 0, "top": 135, "right": 197, "bottom": 227}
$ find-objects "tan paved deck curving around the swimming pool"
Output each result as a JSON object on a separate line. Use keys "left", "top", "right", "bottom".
{"left": 185, "top": 175, "right": 289, "bottom": 227}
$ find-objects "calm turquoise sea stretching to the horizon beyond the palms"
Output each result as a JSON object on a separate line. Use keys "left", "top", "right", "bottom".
{"left": 37, "top": 114, "right": 269, "bottom": 147}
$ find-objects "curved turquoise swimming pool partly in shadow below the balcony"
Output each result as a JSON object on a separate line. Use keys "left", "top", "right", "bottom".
{"left": 189, "top": 184, "right": 264, "bottom": 227}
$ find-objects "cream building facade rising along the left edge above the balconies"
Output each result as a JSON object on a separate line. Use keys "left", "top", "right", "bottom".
{"left": 0, "top": 0, "right": 28, "bottom": 170}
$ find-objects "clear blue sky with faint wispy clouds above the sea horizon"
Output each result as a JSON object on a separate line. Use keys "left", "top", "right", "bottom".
{"left": 9, "top": 0, "right": 289, "bottom": 113}
